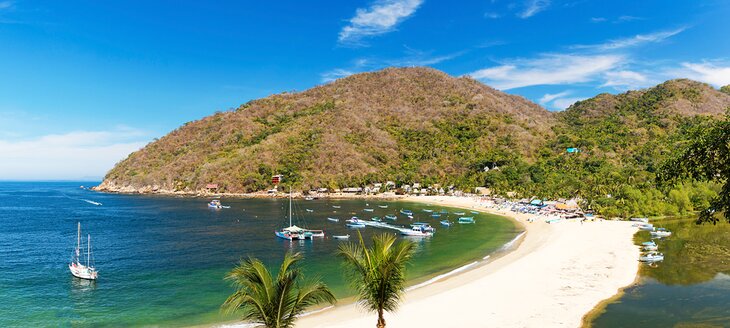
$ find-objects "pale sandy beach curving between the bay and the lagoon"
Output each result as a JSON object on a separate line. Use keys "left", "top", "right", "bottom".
{"left": 297, "top": 196, "right": 639, "bottom": 327}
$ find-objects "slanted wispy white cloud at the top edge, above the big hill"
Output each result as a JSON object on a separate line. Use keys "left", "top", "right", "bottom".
{"left": 339, "top": 0, "right": 423, "bottom": 44}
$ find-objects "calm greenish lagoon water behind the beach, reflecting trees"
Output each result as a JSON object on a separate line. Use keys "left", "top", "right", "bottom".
{"left": 592, "top": 218, "right": 730, "bottom": 328}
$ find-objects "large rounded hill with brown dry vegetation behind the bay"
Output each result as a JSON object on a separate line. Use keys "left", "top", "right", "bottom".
{"left": 96, "top": 68, "right": 555, "bottom": 192}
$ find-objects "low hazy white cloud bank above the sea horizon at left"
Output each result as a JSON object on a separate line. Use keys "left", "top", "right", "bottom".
{"left": 0, "top": 128, "right": 147, "bottom": 180}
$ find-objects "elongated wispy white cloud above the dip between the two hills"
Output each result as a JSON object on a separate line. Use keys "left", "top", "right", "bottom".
{"left": 468, "top": 54, "right": 623, "bottom": 90}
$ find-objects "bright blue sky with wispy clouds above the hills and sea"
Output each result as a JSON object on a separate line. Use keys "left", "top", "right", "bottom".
{"left": 0, "top": 0, "right": 730, "bottom": 180}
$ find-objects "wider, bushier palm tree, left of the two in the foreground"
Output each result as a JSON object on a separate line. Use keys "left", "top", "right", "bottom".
{"left": 222, "top": 253, "right": 336, "bottom": 328}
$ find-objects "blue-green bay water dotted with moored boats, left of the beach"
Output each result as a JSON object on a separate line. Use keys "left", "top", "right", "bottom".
{"left": 0, "top": 182, "right": 520, "bottom": 327}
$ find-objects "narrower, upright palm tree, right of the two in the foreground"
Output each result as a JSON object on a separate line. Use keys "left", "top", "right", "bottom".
{"left": 337, "top": 232, "right": 415, "bottom": 328}
